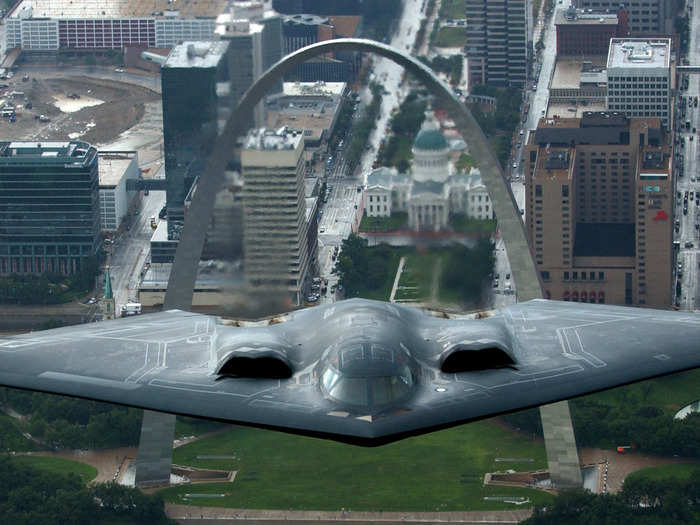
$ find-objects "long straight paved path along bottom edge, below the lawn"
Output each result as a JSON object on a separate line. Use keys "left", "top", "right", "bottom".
{"left": 165, "top": 503, "right": 532, "bottom": 525}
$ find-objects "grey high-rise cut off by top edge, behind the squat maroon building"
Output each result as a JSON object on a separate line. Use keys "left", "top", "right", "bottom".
{"left": 574, "top": 0, "right": 675, "bottom": 36}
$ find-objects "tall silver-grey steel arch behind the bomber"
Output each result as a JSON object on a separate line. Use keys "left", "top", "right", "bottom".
{"left": 136, "top": 38, "right": 582, "bottom": 487}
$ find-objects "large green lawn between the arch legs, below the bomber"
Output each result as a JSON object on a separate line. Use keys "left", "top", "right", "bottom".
{"left": 162, "top": 422, "right": 551, "bottom": 511}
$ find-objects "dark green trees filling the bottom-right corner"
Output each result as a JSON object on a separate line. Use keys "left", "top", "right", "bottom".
{"left": 522, "top": 469, "right": 700, "bottom": 525}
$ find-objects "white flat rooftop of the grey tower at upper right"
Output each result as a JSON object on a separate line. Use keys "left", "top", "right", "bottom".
{"left": 607, "top": 38, "right": 671, "bottom": 69}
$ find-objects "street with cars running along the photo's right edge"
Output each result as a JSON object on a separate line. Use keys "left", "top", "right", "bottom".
{"left": 674, "top": 0, "right": 700, "bottom": 311}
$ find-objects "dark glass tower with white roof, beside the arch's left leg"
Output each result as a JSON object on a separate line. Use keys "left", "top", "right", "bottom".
{"left": 161, "top": 41, "right": 232, "bottom": 239}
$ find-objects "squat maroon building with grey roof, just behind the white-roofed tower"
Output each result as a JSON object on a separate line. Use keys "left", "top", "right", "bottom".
{"left": 554, "top": 6, "right": 629, "bottom": 58}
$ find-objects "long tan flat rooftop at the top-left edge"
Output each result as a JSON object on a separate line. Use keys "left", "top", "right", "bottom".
{"left": 10, "top": 0, "right": 227, "bottom": 19}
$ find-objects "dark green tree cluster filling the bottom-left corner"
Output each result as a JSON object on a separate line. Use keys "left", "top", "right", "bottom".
{"left": 0, "top": 456, "right": 175, "bottom": 525}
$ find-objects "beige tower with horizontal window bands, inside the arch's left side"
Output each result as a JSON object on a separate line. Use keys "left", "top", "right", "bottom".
{"left": 241, "top": 128, "right": 317, "bottom": 304}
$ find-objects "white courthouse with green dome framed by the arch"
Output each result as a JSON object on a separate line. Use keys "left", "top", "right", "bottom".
{"left": 365, "top": 111, "right": 494, "bottom": 231}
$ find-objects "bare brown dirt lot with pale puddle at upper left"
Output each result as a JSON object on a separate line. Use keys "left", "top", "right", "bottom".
{"left": 0, "top": 76, "right": 160, "bottom": 144}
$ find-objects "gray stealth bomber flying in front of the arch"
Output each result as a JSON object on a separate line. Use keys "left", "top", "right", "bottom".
{"left": 0, "top": 299, "right": 700, "bottom": 445}
